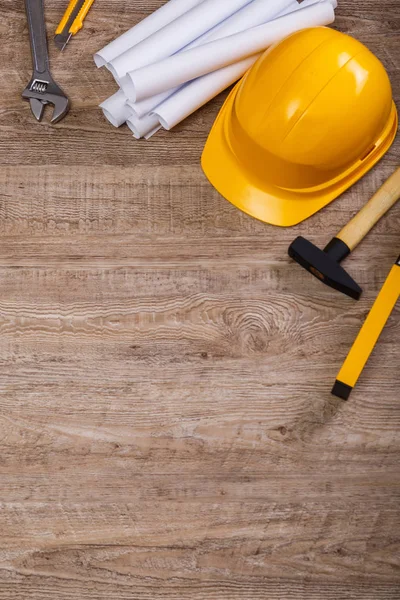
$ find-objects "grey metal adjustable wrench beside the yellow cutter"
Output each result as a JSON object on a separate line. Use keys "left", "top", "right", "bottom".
{"left": 22, "top": 0, "right": 69, "bottom": 123}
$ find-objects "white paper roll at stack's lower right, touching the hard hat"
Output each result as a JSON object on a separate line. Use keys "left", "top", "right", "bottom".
{"left": 152, "top": 53, "right": 262, "bottom": 130}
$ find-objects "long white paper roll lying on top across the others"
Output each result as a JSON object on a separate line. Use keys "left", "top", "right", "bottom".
{"left": 124, "top": 1, "right": 335, "bottom": 102}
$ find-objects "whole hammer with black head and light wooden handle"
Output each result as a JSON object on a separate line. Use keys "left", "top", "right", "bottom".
{"left": 289, "top": 168, "right": 400, "bottom": 300}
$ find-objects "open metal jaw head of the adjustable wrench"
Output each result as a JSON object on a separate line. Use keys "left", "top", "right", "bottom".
{"left": 22, "top": 76, "right": 70, "bottom": 124}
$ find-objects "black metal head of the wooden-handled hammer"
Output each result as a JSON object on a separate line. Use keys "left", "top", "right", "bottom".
{"left": 289, "top": 237, "right": 362, "bottom": 300}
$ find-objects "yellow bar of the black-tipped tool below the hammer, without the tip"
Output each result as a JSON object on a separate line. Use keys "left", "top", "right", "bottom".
{"left": 337, "top": 257, "right": 400, "bottom": 388}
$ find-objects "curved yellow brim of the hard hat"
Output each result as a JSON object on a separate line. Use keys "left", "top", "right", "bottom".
{"left": 201, "top": 82, "right": 398, "bottom": 227}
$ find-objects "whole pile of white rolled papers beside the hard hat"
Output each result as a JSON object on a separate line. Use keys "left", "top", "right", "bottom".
{"left": 94, "top": 0, "right": 337, "bottom": 139}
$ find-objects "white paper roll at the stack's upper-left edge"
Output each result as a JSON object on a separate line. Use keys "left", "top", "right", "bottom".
{"left": 94, "top": 0, "right": 203, "bottom": 67}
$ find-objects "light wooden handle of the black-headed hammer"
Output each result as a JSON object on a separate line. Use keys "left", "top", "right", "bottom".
{"left": 336, "top": 169, "right": 400, "bottom": 250}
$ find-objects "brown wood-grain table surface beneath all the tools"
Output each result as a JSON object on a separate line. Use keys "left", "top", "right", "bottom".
{"left": 0, "top": 0, "right": 400, "bottom": 600}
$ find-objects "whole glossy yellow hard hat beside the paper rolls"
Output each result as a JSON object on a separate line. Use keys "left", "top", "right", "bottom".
{"left": 202, "top": 27, "right": 398, "bottom": 226}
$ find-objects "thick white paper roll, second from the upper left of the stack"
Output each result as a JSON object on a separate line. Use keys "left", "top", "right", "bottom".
{"left": 106, "top": 0, "right": 251, "bottom": 87}
